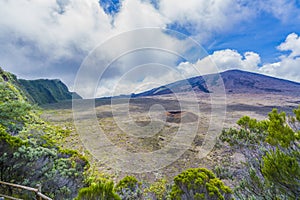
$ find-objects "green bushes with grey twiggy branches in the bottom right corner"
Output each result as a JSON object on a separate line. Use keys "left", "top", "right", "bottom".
{"left": 220, "top": 107, "right": 300, "bottom": 199}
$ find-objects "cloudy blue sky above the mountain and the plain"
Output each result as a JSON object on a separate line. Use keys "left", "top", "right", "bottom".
{"left": 0, "top": 0, "right": 300, "bottom": 98}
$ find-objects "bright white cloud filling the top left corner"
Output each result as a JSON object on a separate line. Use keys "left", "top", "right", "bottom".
{"left": 0, "top": 0, "right": 110, "bottom": 59}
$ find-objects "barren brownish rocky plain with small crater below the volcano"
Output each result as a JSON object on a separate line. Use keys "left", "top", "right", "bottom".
{"left": 42, "top": 94, "right": 300, "bottom": 185}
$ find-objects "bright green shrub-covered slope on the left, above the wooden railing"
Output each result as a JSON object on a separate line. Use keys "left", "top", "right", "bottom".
{"left": 0, "top": 68, "right": 89, "bottom": 199}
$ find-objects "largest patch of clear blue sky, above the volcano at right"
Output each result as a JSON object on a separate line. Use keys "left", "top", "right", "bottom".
{"left": 208, "top": 10, "right": 300, "bottom": 62}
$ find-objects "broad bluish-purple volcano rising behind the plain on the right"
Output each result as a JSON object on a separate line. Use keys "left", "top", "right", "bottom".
{"left": 131, "top": 70, "right": 300, "bottom": 97}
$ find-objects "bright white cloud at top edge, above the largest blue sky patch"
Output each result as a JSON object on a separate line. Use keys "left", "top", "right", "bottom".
{"left": 159, "top": 0, "right": 253, "bottom": 42}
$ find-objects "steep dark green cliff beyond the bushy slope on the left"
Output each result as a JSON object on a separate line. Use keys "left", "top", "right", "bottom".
{"left": 18, "top": 79, "right": 81, "bottom": 105}
